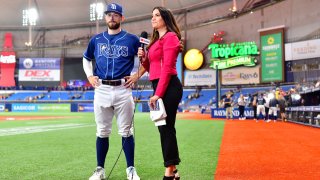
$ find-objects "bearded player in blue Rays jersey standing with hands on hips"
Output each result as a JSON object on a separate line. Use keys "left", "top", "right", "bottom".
{"left": 83, "top": 3, "right": 140, "bottom": 180}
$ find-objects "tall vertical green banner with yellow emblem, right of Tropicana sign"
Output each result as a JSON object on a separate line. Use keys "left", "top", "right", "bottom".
{"left": 260, "top": 28, "right": 284, "bottom": 82}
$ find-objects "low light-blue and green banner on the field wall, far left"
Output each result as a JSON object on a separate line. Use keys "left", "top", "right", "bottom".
{"left": 11, "top": 103, "right": 71, "bottom": 112}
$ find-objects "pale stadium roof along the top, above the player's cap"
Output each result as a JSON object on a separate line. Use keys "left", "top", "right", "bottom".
{"left": 0, "top": 0, "right": 232, "bottom": 29}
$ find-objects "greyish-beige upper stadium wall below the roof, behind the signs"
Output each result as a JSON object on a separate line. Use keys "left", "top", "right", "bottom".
{"left": 0, "top": 0, "right": 320, "bottom": 60}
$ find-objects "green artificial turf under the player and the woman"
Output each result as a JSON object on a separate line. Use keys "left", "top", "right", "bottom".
{"left": 0, "top": 113, "right": 224, "bottom": 180}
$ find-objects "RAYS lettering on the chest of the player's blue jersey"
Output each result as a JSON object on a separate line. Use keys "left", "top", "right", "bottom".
{"left": 98, "top": 43, "right": 128, "bottom": 58}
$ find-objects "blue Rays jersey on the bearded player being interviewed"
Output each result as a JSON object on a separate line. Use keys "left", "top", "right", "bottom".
{"left": 83, "top": 30, "right": 140, "bottom": 80}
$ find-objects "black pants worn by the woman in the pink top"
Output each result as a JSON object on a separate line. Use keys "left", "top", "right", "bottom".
{"left": 152, "top": 76, "right": 183, "bottom": 167}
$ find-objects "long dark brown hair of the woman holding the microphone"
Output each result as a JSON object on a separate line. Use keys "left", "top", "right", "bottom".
{"left": 148, "top": 7, "right": 181, "bottom": 48}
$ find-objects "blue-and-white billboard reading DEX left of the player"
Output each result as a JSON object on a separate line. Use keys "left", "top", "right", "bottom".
{"left": 19, "top": 58, "right": 60, "bottom": 81}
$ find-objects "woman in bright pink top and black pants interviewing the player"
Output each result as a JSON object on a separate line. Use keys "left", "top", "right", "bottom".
{"left": 138, "top": 7, "right": 183, "bottom": 179}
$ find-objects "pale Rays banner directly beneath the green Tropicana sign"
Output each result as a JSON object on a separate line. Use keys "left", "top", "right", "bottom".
{"left": 221, "top": 66, "right": 260, "bottom": 85}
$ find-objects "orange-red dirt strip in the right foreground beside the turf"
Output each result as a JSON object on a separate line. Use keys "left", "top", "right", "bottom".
{"left": 214, "top": 120, "right": 320, "bottom": 180}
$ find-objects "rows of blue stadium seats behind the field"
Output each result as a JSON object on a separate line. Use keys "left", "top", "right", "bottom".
{"left": 0, "top": 85, "right": 298, "bottom": 107}
